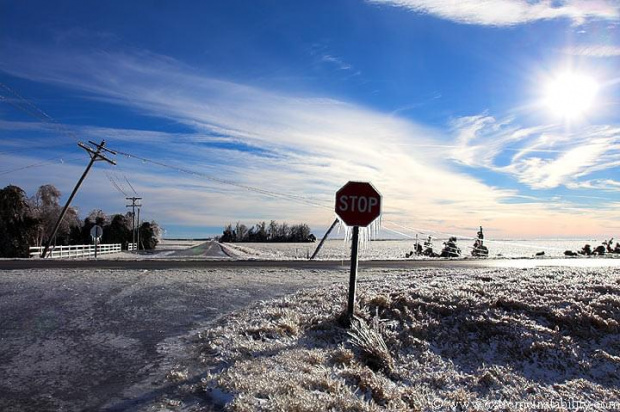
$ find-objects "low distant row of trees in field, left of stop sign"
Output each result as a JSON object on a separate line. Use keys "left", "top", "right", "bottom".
{"left": 219, "top": 220, "right": 316, "bottom": 242}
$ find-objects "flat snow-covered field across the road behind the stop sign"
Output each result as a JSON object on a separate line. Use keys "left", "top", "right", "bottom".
{"left": 219, "top": 239, "right": 603, "bottom": 260}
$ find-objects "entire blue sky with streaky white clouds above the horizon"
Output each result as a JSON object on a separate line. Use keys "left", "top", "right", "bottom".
{"left": 0, "top": 0, "right": 620, "bottom": 238}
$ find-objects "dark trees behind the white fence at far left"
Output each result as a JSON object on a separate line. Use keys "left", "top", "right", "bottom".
{"left": 0, "top": 185, "right": 161, "bottom": 257}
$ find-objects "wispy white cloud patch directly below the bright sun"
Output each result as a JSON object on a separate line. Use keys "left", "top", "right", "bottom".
{"left": 452, "top": 115, "right": 620, "bottom": 189}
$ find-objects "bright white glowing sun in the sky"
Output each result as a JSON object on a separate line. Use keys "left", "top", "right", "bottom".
{"left": 544, "top": 72, "right": 599, "bottom": 120}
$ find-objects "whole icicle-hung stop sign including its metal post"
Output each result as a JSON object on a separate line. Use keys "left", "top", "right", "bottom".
{"left": 336, "top": 182, "right": 381, "bottom": 321}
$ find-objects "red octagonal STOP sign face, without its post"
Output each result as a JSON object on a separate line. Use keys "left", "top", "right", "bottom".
{"left": 336, "top": 182, "right": 381, "bottom": 227}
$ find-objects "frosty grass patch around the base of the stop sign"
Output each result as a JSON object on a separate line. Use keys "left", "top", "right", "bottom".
{"left": 183, "top": 269, "right": 620, "bottom": 411}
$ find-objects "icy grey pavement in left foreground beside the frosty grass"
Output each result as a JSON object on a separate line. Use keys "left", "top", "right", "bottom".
{"left": 0, "top": 268, "right": 354, "bottom": 412}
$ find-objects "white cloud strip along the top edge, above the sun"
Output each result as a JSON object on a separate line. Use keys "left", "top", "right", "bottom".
{"left": 368, "top": 0, "right": 620, "bottom": 26}
